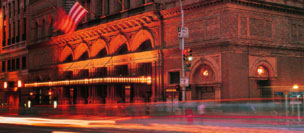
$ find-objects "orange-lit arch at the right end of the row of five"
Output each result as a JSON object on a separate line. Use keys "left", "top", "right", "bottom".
{"left": 131, "top": 29, "right": 155, "bottom": 51}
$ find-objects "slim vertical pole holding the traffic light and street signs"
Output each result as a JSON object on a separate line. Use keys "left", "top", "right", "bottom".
{"left": 179, "top": 0, "right": 186, "bottom": 101}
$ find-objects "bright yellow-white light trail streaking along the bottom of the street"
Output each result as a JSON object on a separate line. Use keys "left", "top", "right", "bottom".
{"left": 0, "top": 117, "right": 300, "bottom": 133}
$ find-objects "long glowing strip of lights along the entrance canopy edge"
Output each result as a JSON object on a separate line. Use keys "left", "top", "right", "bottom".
{"left": 24, "top": 76, "right": 152, "bottom": 88}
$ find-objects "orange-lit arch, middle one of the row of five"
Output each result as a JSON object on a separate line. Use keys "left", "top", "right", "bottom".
{"left": 90, "top": 39, "right": 109, "bottom": 57}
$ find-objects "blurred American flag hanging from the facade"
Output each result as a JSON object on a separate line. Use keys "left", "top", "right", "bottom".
{"left": 53, "top": 2, "right": 88, "bottom": 34}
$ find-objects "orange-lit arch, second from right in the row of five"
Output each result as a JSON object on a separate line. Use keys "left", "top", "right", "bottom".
{"left": 109, "top": 34, "right": 130, "bottom": 54}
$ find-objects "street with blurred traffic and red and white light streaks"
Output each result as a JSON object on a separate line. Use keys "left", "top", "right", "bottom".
{"left": 0, "top": 98, "right": 304, "bottom": 132}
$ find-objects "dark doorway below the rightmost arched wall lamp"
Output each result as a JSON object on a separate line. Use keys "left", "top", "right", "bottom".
{"left": 257, "top": 80, "right": 272, "bottom": 98}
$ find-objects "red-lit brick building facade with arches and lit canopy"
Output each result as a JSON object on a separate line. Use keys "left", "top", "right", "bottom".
{"left": 1, "top": 0, "right": 304, "bottom": 104}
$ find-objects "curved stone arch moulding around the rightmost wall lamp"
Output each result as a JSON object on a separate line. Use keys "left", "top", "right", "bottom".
{"left": 249, "top": 58, "right": 276, "bottom": 77}
